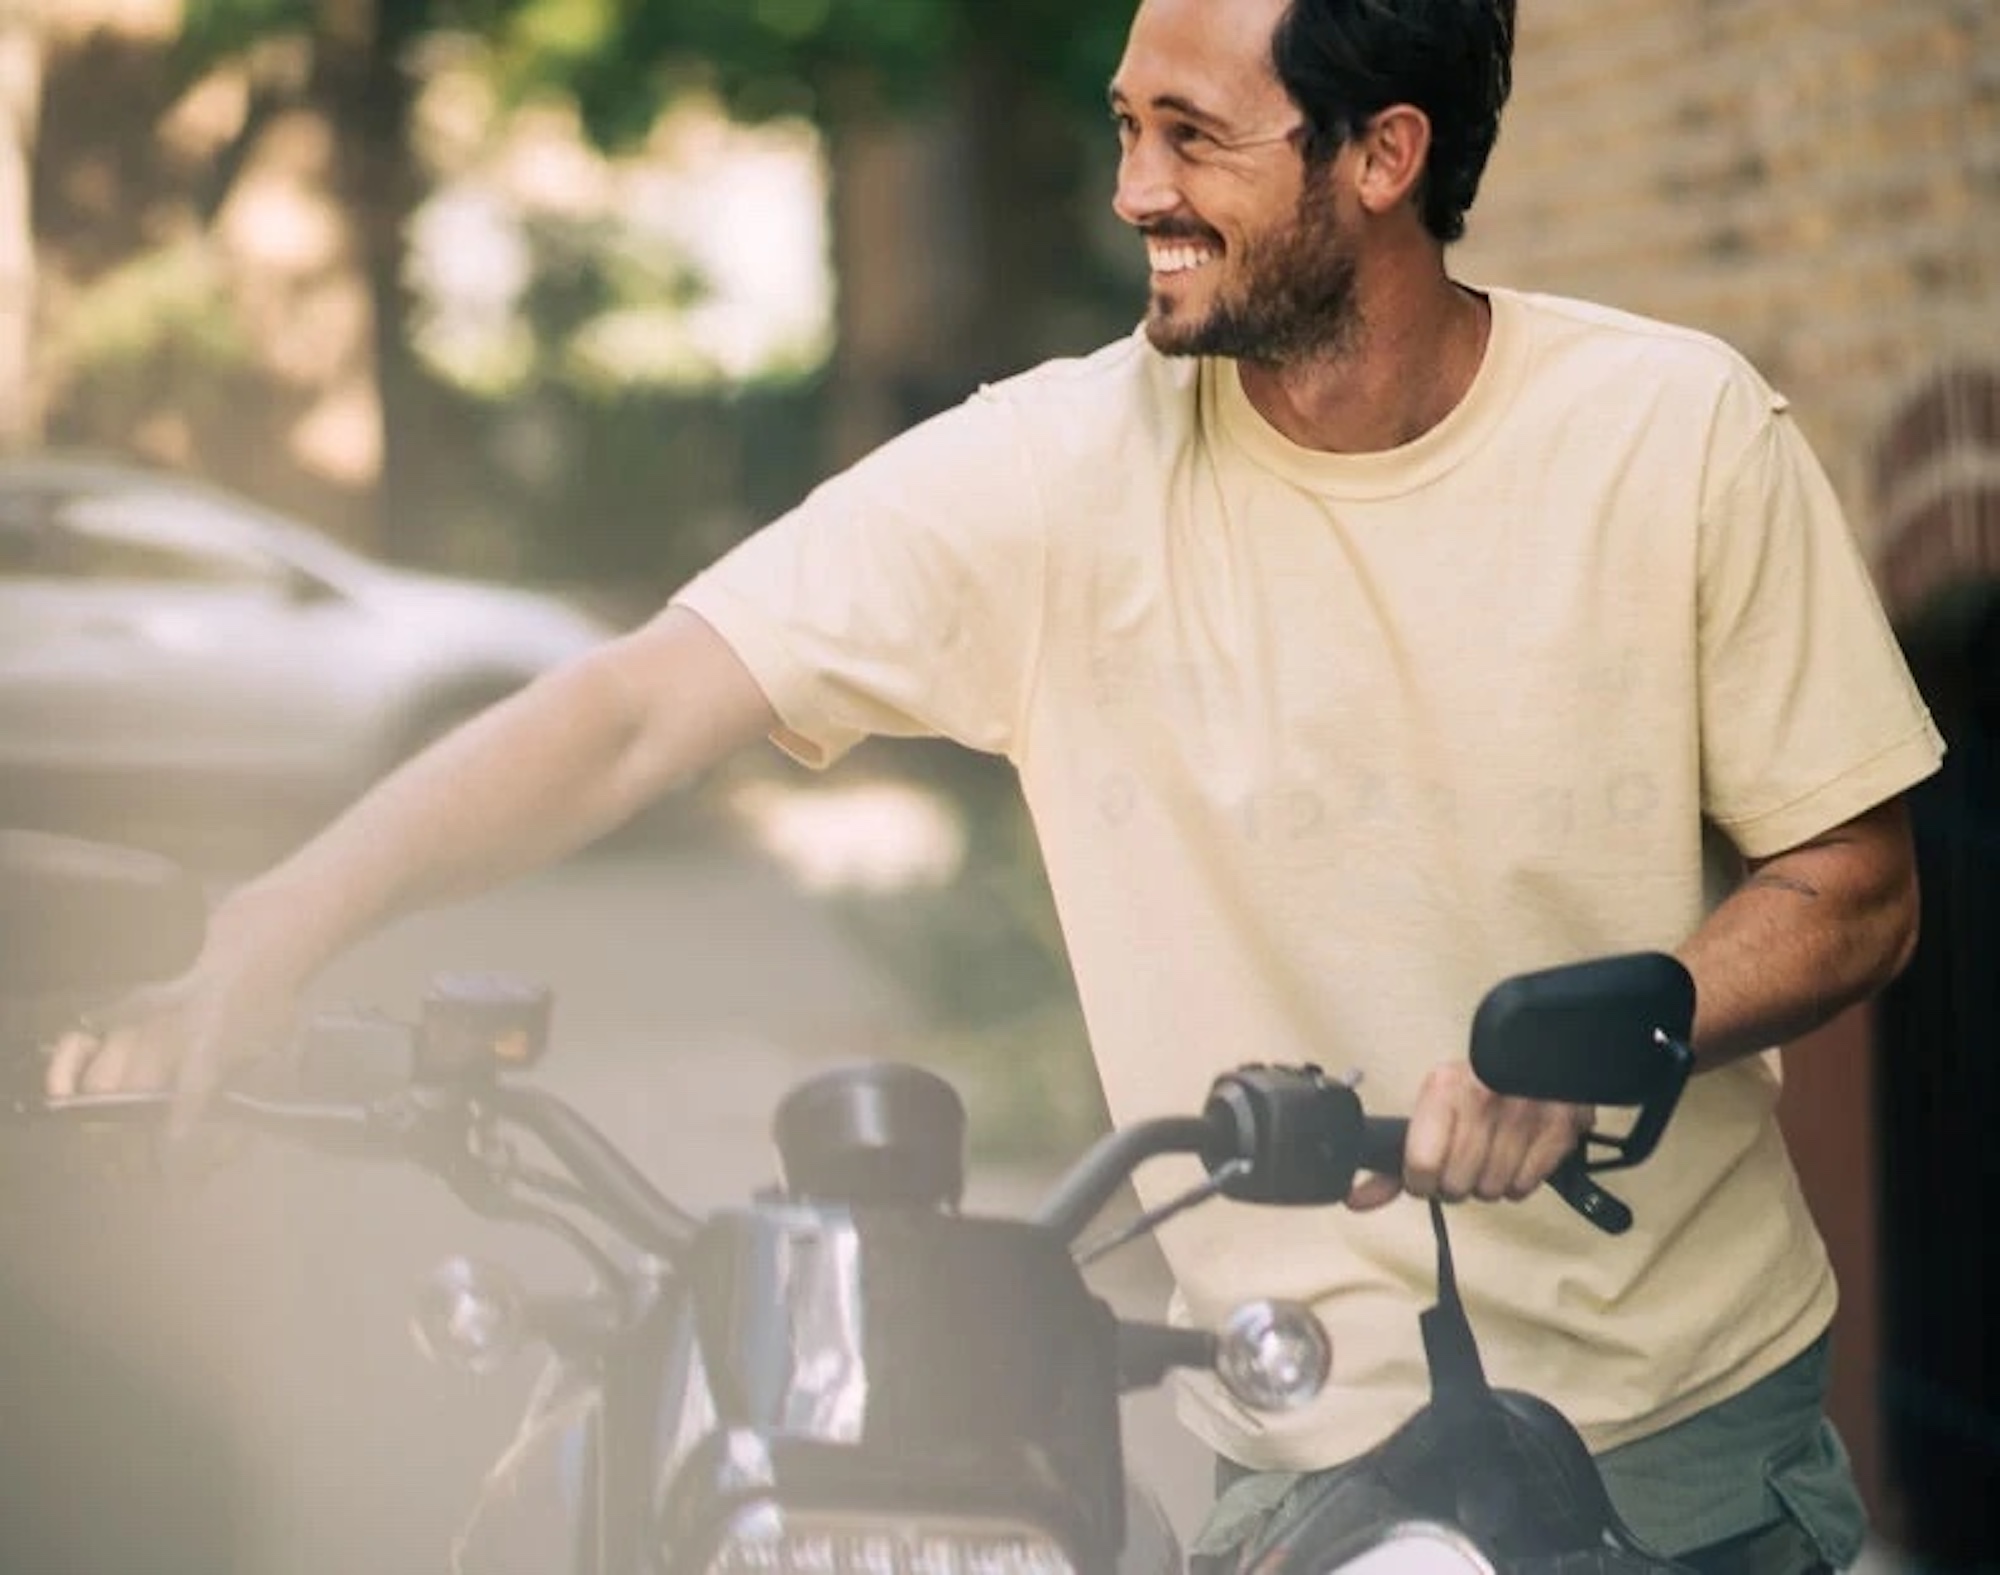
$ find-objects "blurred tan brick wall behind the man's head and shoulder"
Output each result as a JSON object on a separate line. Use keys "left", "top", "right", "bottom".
{"left": 1456, "top": 0, "right": 2000, "bottom": 567}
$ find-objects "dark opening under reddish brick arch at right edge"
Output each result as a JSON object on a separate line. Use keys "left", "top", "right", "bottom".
{"left": 1874, "top": 368, "right": 2000, "bottom": 1569}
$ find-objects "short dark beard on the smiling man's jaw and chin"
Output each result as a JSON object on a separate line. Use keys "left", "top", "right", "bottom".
{"left": 1146, "top": 184, "right": 1358, "bottom": 366}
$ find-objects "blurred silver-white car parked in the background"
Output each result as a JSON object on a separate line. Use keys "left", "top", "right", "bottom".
{"left": 0, "top": 456, "right": 612, "bottom": 847}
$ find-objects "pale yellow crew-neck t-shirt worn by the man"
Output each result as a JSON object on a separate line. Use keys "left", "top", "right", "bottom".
{"left": 678, "top": 290, "right": 1942, "bottom": 1467}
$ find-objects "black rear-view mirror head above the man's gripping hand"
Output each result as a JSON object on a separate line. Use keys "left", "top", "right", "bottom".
{"left": 1472, "top": 951, "right": 1694, "bottom": 1105}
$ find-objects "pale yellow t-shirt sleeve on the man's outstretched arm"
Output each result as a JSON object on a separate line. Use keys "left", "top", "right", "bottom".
{"left": 674, "top": 394, "right": 1046, "bottom": 766}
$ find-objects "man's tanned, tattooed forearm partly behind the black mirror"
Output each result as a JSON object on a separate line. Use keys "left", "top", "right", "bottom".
{"left": 1680, "top": 795, "right": 1918, "bottom": 1071}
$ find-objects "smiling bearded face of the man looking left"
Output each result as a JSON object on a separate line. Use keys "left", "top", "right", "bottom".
{"left": 1110, "top": 0, "right": 1354, "bottom": 364}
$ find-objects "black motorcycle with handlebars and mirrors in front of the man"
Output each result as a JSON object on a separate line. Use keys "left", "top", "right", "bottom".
{"left": 0, "top": 833, "right": 1694, "bottom": 1575}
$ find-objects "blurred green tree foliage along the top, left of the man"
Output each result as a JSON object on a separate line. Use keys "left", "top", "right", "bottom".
{"left": 164, "top": 0, "right": 1132, "bottom": 437}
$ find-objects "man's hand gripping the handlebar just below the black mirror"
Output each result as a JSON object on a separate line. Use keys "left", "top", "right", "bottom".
{"left": 1348, "top": 1061, "right": 1596, "bottom": 1211}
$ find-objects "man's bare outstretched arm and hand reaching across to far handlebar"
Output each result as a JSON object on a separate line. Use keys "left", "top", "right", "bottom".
{"left": 48, "top": 608, "right": 776, "bottom": 1097}
